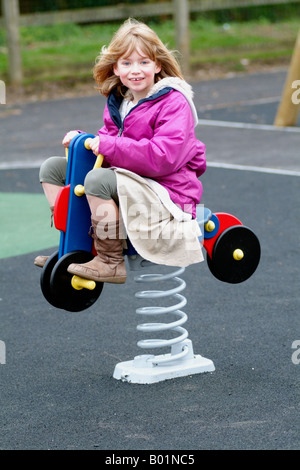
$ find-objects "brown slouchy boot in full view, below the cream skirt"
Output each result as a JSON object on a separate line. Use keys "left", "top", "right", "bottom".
{"left": 67, "top": 219, "right": 126, "bottom": 284}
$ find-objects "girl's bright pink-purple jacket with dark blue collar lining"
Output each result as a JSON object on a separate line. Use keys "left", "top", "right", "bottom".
{"left": 98, "top": 81, "right": 206, "bottom": 217}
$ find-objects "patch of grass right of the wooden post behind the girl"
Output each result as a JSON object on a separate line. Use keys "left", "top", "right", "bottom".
{"left": 191, "top": 20, "right": 299, "bottom": 71}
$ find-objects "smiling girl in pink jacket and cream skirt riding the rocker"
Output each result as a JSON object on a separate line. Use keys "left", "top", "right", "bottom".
{"left": 35, "top": 19, "right": 206, "bottom": 283}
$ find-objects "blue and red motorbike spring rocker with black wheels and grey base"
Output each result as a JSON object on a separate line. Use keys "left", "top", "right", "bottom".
{"left": 40, "top": 134, "right": 260, "bottom": 384}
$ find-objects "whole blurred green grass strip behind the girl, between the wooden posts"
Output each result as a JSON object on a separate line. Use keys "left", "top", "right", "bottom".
{"left": 0, "top": 19, "right": 299, "bottom": 84}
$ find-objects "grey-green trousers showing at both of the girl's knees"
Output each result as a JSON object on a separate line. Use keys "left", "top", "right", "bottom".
{"left": 40, "top": 157, "right": 119, "bottom": 203}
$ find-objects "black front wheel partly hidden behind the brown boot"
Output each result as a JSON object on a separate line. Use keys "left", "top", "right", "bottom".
{"left": 50, "top": 251, "right": 103, "bottom": 312}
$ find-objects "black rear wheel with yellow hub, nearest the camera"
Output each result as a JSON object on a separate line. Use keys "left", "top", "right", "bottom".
{"left": 207, "top": 225, "right": 260, "bottom": 284}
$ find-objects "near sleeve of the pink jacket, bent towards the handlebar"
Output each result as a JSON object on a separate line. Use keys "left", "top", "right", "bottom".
{"left": 99, "top": 92, "right": 204, "bottom": 178}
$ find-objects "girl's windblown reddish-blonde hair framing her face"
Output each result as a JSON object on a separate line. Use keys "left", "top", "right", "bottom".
{"left": 94, "top": 18, "right": 183, "bottom": 96}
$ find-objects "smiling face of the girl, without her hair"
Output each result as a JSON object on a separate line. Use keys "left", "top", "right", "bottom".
{"left": 114, "top": 49, "right": 161, "bottom": 103}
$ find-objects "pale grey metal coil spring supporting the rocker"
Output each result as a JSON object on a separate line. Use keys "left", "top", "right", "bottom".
{"left": 134, "top": 268, "right": 188, "bottom": 364}
